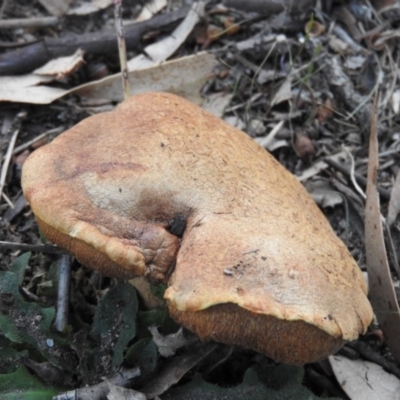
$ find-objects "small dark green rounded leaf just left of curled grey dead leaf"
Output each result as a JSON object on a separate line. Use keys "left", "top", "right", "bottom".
{"left": 125, "top": 338, "right": 158, "bottom": 375}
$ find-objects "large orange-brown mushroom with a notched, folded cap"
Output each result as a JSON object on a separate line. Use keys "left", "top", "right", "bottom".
{"left": 22, "top": 93, "right": 373, "bottom": 364}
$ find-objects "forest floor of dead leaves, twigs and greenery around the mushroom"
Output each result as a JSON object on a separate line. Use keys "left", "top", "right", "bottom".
{"left": 0, "top": 0, "right": 400, "bottom": 400}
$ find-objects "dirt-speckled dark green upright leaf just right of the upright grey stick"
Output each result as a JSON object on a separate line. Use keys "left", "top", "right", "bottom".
{"left": 91, "top": 283, "right": 138, "bottom": 368}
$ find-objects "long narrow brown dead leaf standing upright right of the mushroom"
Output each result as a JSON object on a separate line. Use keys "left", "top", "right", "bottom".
{"left": 365, "top": 90, "right": 400, "bottom": 361}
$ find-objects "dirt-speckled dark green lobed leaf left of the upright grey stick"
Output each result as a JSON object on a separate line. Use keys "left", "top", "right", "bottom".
{"left": 0, "top": 271, "right": 75, "bottom": 370}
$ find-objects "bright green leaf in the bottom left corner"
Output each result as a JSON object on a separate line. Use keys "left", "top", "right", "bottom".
{"left": 0, "top": 367, "right": 62, "bottom": 400}
